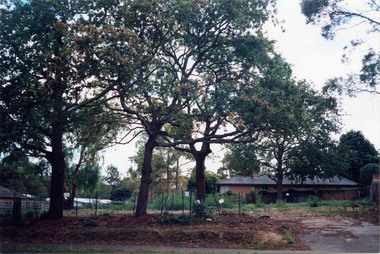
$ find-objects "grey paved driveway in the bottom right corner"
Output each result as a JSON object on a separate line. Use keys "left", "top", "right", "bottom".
{"left": 301, "top": 219, "right": 380, "bottom": 253}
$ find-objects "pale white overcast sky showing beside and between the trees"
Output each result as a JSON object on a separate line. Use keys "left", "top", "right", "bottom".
{"left": 103, "top": 0, "right": 380, "bottom": 176}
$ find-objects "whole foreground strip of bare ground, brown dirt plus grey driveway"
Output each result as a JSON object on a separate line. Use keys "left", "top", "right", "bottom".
{"left": 1, "top": 207, "right": 379, "bottom": 253}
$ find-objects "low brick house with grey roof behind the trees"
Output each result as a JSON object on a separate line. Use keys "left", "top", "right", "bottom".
{"left": 216, "top": 175, "right": 359, "bottom": 203}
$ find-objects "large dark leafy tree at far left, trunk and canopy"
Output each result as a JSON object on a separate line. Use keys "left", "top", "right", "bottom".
{"left": 0, "top": 1, "right": 121, "bottom": 219}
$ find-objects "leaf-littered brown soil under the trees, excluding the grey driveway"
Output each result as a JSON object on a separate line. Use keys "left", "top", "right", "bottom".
{"left": 1, "top": 208, "right": 378, "bottom": 250}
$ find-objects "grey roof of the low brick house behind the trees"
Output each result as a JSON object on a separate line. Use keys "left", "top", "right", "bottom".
{"left": 216, "top": 175, "right": 358, "bottom": 186}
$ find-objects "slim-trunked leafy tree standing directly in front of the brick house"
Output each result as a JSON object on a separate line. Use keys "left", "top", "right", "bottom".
{"left": 251, "top": 75, "right": 338, "bottom": 200}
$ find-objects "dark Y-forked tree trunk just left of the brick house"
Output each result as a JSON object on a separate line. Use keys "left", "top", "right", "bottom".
{"left": 191, "top": 143, "right": 211, "bottom": 202}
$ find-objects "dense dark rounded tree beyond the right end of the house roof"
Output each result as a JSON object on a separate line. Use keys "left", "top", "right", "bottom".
{"left": 339, "top": 130, "right": 379, "bottom": 183}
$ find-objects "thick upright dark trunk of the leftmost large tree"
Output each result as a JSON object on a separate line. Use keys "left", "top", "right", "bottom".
{"left": 47, "top": 124, "right": 66, "bottom": 219}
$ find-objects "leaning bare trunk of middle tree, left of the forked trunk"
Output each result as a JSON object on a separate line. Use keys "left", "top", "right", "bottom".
{"left": 136, "top": 137, "right": 156, "bottom": 217}
